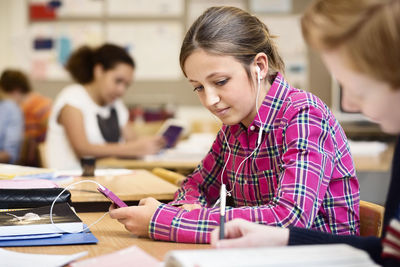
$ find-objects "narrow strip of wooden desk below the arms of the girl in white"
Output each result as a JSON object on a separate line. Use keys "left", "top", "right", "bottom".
{"left": 96, "top": 158, "right": 200, "bottom": 174}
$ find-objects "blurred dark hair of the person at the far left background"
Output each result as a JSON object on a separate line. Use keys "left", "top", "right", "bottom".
{"left": 0, "top": 69, "right": 32, "bottom": 94}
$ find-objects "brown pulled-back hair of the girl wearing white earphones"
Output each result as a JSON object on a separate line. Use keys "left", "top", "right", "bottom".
{"left": 179, "top": 7, "right": 285, "bottom": 83}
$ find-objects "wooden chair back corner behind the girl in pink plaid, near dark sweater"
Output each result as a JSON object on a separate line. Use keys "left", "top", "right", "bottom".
{"left": 360, "top": 200, "right": 385, "bottom": 237}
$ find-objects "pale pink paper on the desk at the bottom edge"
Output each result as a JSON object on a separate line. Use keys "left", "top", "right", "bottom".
{"left": 70, "top": 246, "right": 162, "bottom": 267}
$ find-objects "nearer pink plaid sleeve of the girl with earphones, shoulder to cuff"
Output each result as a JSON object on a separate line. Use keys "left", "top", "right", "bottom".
{"left": 150, "top": 101, "right": 358, "bottom": 243}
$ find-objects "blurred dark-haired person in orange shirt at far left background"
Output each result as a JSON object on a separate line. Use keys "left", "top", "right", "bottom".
{"left": 0, "top": 69, "right": 51, "bottom": 166}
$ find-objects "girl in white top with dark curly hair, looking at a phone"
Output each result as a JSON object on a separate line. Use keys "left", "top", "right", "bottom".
{"left": 46, "top": 44, "right": 164, "bottom": 169}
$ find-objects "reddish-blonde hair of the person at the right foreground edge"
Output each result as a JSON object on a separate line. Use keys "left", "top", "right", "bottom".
{"left": 301, "top": 0, "right": 400, "bottom": 89}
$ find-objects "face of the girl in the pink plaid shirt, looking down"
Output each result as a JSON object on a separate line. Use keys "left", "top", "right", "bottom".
{"left": 184, "top": 49, "right": 265, "bottom": 127}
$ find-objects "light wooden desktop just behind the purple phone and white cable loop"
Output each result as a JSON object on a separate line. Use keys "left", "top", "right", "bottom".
{"left": 59, "top": 170, "right": 178, "bottom": 211}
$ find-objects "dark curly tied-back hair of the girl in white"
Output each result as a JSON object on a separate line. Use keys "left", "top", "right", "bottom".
{"left": 65, "top": 44, "right": 135, "bottom": 84}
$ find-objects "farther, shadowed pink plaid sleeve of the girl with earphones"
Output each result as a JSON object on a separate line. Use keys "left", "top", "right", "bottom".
{"left": 169, "top": 129, "right": 224, "bottom": 206}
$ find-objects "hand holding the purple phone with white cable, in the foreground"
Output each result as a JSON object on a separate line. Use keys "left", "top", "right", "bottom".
{"left": 109, "top": 197, "right": 161, "bottom": 237}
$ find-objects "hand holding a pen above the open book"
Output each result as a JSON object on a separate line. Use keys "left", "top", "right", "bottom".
{"left": 211, "top": 219, "right": 289, "bottom": 248}
